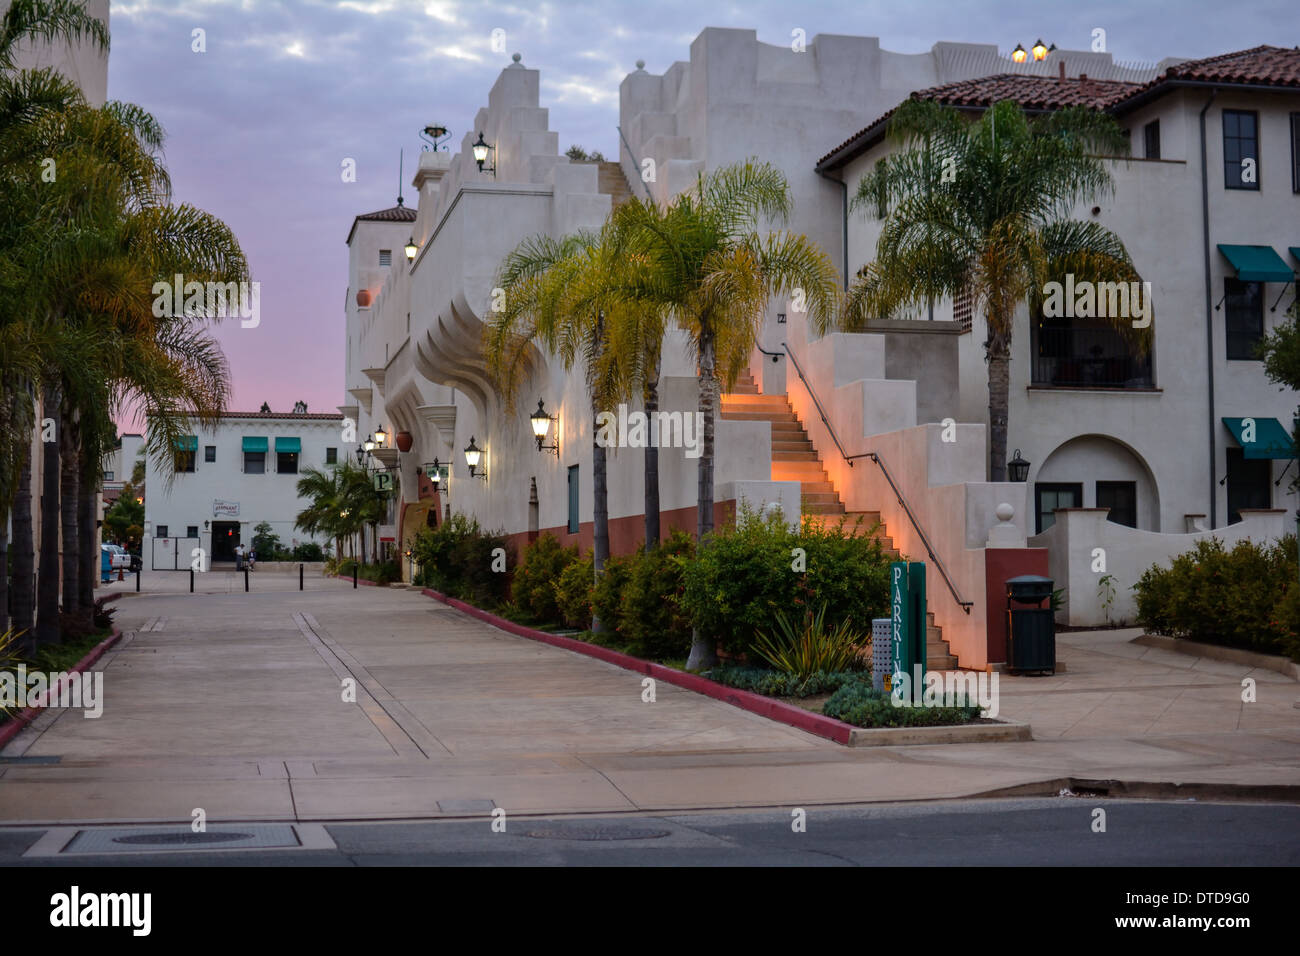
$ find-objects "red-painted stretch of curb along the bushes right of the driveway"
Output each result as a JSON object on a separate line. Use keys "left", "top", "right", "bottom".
{"left": 420, "top": 588, "right": 854, "bottom": 744}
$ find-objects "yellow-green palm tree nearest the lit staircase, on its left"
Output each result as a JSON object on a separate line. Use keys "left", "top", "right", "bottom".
{"left": 615, "top": 161, "right": 839, "bottom": 669}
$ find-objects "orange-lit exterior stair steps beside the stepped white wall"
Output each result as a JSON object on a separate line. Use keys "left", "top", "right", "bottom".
{"left": 722, "top": 369, "right": 957, "bottom": 670}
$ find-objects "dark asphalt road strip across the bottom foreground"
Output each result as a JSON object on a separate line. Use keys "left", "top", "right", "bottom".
{"left": 0, "top": 796, "right": 1300, "bottom": 868}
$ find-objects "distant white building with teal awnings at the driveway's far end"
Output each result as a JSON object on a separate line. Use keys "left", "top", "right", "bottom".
{"left": 143, "top": 412, "right": 350, "bottom": 571}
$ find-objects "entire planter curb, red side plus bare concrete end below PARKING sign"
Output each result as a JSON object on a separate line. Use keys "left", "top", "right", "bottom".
{"left": 420, "top": 588, "right": 1034, "bottom": 747}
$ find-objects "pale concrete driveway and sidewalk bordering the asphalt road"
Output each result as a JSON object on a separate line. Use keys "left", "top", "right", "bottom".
{"left": 0, "top": 572, "right": 1300, "bottom": 825}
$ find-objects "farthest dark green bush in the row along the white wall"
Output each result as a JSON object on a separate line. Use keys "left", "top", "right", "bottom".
{"left": 411, "top": 514, "right": 506, "bottom": 607}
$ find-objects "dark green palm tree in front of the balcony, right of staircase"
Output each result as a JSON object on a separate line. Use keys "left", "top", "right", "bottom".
{"left": 837, "top": 100, "right": 1149, "bottom": 481}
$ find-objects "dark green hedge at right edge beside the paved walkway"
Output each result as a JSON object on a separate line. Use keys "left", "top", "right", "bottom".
{"left": 1134, "top": 535, "right": 1300, "bottom": 659}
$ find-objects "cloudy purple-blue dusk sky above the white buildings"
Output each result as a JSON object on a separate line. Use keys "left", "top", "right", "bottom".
{"left": 108, "top": 0, "right": 1300, "bottom": 428}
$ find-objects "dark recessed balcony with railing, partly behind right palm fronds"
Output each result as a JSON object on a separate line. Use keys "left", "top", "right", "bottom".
{"left": 1030, "top": 320, "right": 1156, "bottom": 389}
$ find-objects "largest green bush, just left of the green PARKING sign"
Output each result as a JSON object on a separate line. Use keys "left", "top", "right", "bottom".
{"left": 680, "top": 511, "right": 892, "bottom": 654}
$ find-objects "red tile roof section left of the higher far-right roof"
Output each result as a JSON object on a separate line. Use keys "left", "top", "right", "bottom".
{"left": 818, "top": 73, "right": 1141, "bottom": 168}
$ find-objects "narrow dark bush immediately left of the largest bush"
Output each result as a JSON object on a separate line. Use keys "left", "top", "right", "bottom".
{"left": 616, "top": 531, "right": 696, "bottom": 661}
